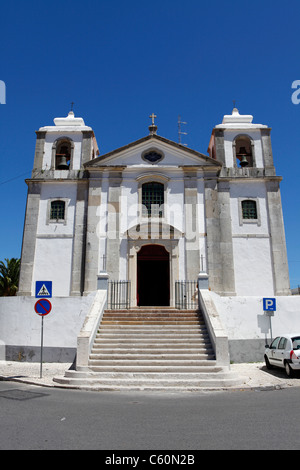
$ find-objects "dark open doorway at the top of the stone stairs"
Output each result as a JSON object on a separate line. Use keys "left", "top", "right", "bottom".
{"left": 137, "top": 245, "right": 170, "bottom": 307}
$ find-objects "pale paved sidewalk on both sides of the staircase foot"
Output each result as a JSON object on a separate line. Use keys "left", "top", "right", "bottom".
{"left": 0, "top": 361, "right": 300, "bottom": 390}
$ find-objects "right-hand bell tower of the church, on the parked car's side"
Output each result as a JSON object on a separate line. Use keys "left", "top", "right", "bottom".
{"left": 208, "top": 108, "right": 290, "bottom": 295}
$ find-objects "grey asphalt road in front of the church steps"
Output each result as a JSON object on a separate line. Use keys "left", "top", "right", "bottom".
{"left": 0, "top": 382, "right": 300, "bottom": 452}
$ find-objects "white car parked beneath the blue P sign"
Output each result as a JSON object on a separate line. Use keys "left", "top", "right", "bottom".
{"left": 264, "top": 334, "right": 300, "bottom": 377}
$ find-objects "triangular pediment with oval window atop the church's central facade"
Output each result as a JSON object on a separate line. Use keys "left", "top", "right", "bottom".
{"left": 85, "top": 134, "right": 221, "bottom": 169}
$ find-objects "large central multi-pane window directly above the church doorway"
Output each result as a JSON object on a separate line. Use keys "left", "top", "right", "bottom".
{"left": 142, "top": 181, "right": 165, "bottom": 217}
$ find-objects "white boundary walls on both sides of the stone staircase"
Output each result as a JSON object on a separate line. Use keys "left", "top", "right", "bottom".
{"left": 0, "top": 290, "right": 300, "bottom": 362}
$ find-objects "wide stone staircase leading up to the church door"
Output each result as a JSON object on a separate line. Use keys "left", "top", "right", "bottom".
{"left": 54, "top": 307, "right": 241, "bottom": 390}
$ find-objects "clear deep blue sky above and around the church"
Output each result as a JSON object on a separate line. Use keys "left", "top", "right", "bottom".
{"left": 0, "top": 0, "right": 300, "bottom": 287}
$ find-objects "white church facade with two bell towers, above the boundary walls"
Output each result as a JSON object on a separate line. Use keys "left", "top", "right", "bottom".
{"left": 19, "top": 109, "right": 289, "bottom": 307}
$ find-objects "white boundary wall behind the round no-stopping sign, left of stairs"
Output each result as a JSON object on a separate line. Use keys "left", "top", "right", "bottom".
{"left": 0, "top": 292, "right": 95, "bottom": 362}
